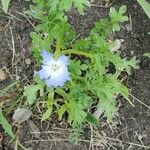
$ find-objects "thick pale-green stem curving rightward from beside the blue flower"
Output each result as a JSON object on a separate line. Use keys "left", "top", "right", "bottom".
{"left": 61, "top": 49, "right": 92, "bottom": 58}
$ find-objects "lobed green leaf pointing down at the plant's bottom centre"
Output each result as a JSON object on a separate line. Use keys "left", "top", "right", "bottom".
{"left": 66, "top": 85, "right": 91, "bottom": 127}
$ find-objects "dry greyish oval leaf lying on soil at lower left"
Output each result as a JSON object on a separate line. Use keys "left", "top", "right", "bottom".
{"left": 13, "top": 108, "right": 32, "bottom": 124}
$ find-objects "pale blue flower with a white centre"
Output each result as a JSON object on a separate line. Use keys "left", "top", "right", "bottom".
{"left": 36, "top": 50, "right": 70, "bottom": 87}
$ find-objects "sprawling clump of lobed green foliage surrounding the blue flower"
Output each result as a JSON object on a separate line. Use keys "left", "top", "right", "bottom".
{"left": 24, "top": 0, "right": 138, "bottom": 142}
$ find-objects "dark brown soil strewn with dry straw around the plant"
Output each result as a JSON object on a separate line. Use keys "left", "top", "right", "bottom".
{"left": 0, "top": 0, "right": 150, "bottom": 150}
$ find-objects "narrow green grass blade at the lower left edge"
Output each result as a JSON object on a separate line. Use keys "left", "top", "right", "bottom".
{"left": 0, "top": 109, "right": 15, "bottom": 139}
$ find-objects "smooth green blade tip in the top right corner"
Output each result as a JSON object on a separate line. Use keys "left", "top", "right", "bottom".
{"left": 137, "top": 0, "right": 150, "bottom": 19}
